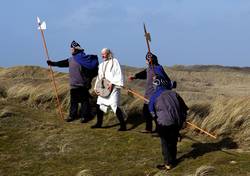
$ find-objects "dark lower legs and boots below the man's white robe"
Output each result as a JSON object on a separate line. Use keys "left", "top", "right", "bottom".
{"left": 96, "top": 105, "right": 126, "bottom": 129}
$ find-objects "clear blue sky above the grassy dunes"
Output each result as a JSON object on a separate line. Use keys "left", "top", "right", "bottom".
{"left": 0, "top": 0, "right": 250, "bottom": 67}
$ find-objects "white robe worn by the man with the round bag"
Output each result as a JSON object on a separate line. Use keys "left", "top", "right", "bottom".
{"left": 95, "top": 58, "right": 124, "bottom": 113}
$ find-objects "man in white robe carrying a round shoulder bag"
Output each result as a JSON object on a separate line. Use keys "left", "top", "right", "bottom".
{"left": 91, "top": 48, "right": 126, "bottom": 131}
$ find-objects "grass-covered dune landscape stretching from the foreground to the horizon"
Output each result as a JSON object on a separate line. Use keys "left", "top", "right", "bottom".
{"left": 0, "top": 65, "right": 250, "bottom": 176}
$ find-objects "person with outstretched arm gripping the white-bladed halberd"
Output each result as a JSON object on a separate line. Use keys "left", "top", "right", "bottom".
{"left": 47, "top": 40, "right": 99, "bottom": 123}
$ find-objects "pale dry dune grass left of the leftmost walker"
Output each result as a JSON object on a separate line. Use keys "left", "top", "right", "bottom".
{"left": 0, "top": 66, "right": 69, "bottom": 108}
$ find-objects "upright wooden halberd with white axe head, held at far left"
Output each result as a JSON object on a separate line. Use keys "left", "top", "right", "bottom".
{"left": 37, "top": 17, "right": 63, "bottom": 119}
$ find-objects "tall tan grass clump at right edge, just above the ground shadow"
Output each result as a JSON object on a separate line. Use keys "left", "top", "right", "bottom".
{"left": 191, "top": 97, "right": 250, "bottom": 144}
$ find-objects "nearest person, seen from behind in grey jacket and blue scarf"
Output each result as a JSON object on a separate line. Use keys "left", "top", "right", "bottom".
{"left": 149, "top": 75, "right": 188, "bottom": 170}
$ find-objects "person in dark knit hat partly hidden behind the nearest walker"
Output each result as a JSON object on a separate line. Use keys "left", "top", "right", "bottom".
{"left": 128, "top": 53, "right": 176, "bottom": 133}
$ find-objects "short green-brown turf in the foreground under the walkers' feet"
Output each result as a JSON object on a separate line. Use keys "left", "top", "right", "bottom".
{"left": 0, "top": 99, "right": 250, "bottom": 176}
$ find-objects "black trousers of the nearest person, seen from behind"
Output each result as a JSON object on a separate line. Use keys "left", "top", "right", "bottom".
{"left": 158, "top": 125, "right": 179, "bottom": 165}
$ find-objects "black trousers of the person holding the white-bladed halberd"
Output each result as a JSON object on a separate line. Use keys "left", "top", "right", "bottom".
{"left": 69, "top": 87, "right": 90, "bottom": 119}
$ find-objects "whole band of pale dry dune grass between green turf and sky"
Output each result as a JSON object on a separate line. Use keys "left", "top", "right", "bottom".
{"left": 0, "top": 66, "right": 250, "bottom": 146}
